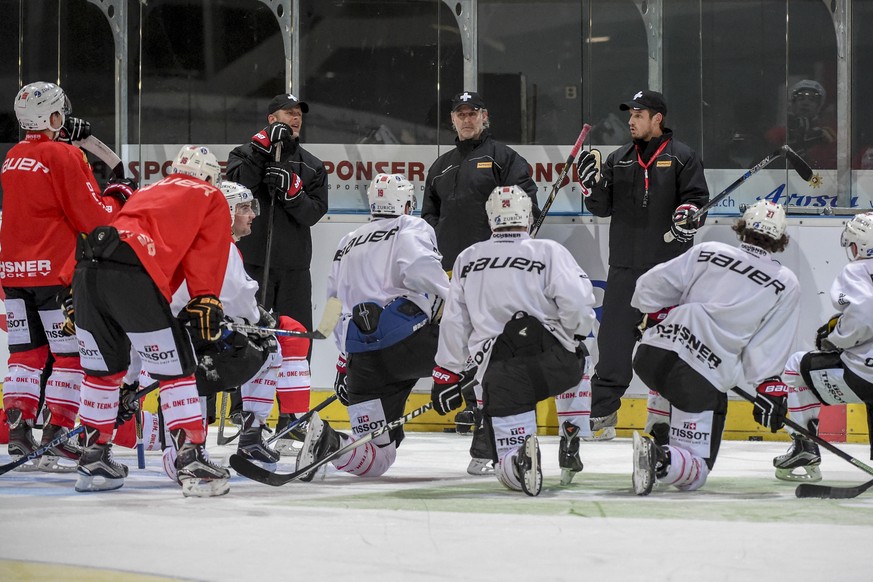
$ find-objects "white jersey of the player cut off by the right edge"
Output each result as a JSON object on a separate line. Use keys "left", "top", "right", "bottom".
{"left": 828, "top": 259, "right": 873, "bottom": 382}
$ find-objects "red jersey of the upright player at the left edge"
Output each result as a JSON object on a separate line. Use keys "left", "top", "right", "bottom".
{"left": 0, "top": 133, "right": 119, "bottom": 287}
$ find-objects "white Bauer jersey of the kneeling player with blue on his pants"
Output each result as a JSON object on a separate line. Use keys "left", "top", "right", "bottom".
{"left": 327, "top": 215, "right": 449, "bottom": 353}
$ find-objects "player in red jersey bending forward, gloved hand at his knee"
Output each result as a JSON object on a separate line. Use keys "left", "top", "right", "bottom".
{"left": 68, "top": 146, "right": 232, "bottom": 496}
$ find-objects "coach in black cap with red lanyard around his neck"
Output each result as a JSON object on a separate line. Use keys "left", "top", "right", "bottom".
{"left": 578, "top": 90, "right": 709, "bottom": 444}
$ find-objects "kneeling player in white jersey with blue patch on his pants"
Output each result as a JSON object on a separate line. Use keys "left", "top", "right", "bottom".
{"left": 297, "top": 174, "right": 449, "bottom": 481}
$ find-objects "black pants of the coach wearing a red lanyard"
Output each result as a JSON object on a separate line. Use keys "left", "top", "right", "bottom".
{"left": 591, "top": 267, "right": 648, "bottom": 418}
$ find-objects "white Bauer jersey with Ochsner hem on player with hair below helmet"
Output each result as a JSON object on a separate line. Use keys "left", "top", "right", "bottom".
{"left": 631, "top": 242, "right": 800, "bottom": 392}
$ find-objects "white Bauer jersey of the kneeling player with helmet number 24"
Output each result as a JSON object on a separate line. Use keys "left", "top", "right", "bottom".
{"left": 436, "top": 232, "right": 595, "bottom": 381}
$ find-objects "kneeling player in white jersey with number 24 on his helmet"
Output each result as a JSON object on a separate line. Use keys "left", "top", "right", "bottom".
{"left": 432, "top": 186, "right": 594, "bottom": 496}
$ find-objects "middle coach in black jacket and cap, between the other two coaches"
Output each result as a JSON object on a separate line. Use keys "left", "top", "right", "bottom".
{"left": 421, "top": 91, "right": 540, "bottom": 271}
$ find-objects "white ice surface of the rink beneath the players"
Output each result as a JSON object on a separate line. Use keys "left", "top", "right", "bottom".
{"left": 0, "top": 431, "right": 873, "bottom": 582}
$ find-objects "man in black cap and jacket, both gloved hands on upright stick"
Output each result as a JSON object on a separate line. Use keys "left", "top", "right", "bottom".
{"left": 227, "top": 93, "right": 328, "bottom": 451}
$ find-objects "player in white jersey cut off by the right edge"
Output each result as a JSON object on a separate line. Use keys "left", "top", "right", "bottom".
{"left": 773, "top": 212, "right": 873, "bottom": 481}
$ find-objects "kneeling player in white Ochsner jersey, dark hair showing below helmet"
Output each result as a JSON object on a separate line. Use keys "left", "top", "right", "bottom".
{"left": 631, "top": 200, "right": 800, "bottom": 495}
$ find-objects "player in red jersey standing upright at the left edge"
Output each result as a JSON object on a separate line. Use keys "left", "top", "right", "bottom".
{"left": 0, "top": 82, "right": 129, "bottom": 471}
